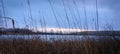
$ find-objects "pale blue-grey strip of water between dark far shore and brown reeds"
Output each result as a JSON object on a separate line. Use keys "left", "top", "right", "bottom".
{"left": 0, "top": 35, "right": 120, "bottom": 40}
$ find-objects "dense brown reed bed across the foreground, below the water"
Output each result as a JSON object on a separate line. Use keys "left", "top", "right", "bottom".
{"left": 0, "top": 37, "right": 120, "bottom": 54}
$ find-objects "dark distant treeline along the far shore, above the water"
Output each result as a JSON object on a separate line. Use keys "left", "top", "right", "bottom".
{"left": 0, "top": 28, "right": 120, "bottom": 36}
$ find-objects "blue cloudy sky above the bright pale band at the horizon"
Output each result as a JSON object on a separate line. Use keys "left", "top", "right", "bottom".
{"left": 0, "top": 0, "right": 120, "bottom": 30}
